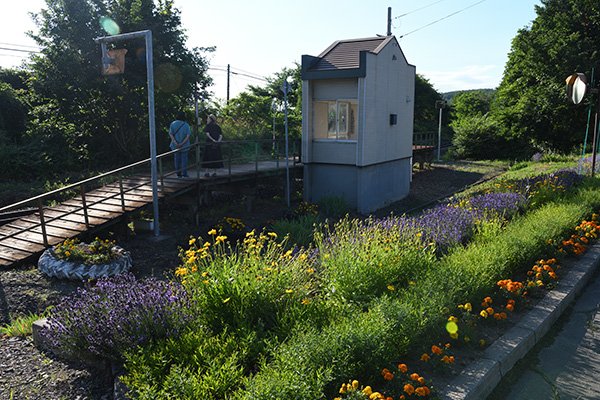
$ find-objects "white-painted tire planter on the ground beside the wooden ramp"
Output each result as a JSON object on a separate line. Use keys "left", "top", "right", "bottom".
{"left": 38, "top": 246, "right": 132, "bottom": 281}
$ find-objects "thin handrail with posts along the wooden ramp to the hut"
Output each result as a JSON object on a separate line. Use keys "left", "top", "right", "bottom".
{"left": 0, "top": 139, "right": 300, "bottom": 247}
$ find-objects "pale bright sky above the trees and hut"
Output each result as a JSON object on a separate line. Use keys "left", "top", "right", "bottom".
{"left": 0, "top": 0, "right": 541, "bottom": 99}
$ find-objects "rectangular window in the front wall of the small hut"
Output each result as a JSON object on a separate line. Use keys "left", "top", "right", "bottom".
{"left": 313, "top": 101, "right": 357, "bottom": 140}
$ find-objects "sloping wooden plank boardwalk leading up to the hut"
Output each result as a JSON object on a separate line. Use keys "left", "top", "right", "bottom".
{"left": 0, "top": 161, "right": 297, "bottom": 267}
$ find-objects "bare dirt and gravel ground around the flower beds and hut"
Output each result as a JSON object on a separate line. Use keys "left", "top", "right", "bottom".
{"left": 0, "top": 163, "right": 500, "bottom": 400}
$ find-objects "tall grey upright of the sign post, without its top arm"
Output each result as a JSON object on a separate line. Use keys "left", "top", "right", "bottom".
{"left": 145, "top": 31, "right": 160, "bottom": 236}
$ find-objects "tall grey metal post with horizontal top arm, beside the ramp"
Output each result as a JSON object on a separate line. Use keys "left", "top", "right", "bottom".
{"left": 94, "top": 30, "right": 160, "bottom": 236}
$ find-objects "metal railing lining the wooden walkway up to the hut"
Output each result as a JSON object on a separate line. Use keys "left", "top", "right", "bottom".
{"left": 0, "top": 139, "right": 300, "bottom": 247}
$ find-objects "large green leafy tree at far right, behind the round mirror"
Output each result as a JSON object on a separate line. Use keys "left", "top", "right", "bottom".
{"left": 492, "top": 0, "right": 600, "bottom": 152}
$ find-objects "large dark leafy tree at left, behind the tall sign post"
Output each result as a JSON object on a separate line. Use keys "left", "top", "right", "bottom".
{"left": 30, "top": 0, "right": 212, "bottom": 167}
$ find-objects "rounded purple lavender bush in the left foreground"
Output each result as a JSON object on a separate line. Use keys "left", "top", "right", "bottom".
{"left": 42, "top": 274, "right": 191, "bottom": 360}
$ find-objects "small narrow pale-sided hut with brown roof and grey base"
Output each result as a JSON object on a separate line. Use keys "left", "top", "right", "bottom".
{"left": 302, "top": 36, "right": 415, "bottom": 214}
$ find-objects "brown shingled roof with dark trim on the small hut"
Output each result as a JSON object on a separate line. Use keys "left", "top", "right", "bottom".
{"left": 310, "top": 36, "right": 392, "bottom": 71}
